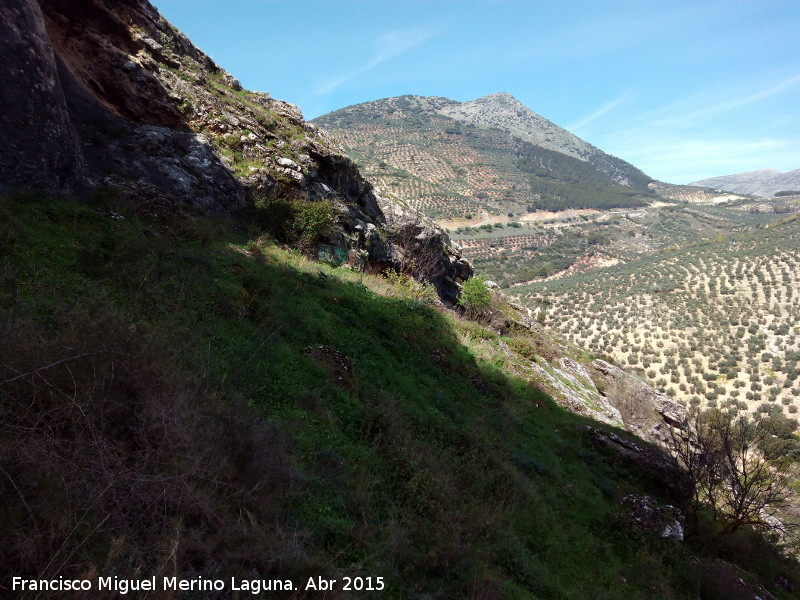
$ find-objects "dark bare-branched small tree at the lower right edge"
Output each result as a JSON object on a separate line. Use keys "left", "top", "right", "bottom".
{"left": 672, "top": 410, "right": 794, "bottom": 535}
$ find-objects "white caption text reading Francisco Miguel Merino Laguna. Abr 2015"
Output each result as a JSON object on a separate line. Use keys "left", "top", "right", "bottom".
{"left": 11, "top": 575, "right": 384, "bottom": 595}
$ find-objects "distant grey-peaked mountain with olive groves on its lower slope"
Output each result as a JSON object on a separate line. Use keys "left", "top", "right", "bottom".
{"left": 313, "top": 93, "right": 654, "bottom": 218}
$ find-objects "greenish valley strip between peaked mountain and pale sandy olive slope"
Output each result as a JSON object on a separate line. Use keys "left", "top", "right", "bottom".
{"left": 451, "top": 198, "right": 800, "bottom": 287}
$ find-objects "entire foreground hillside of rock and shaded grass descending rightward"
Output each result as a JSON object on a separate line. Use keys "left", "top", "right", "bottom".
{"left": 0, "top": 0, "right": 800, "bottom": 600}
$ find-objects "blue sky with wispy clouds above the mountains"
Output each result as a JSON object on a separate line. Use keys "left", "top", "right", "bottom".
{"left": 153, "top": 0, "right": 800, "bottom": 183}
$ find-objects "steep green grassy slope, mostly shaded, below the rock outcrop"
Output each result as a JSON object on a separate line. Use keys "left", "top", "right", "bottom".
{"left": 0, "top": 195, "right": 797, "bottom": 599}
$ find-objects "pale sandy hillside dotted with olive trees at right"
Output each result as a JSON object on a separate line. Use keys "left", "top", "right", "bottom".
{"left": 515, "top": 215, "right": 800, "bottom": 415}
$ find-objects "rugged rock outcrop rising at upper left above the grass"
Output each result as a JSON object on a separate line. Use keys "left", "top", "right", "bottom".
{"left": 0, "top": 0, "right": 472, "bottom": 302}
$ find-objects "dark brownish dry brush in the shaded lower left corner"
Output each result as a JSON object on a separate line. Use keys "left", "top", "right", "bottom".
{"left": 0, "top": 314, "right": 303, "bottom": 596}
